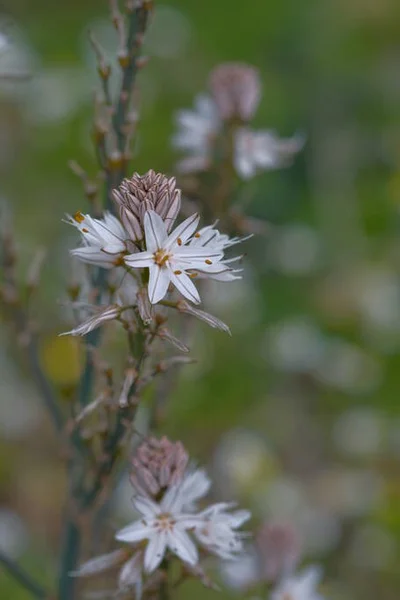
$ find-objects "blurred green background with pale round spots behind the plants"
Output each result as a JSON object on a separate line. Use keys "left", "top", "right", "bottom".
{"left": 0, "top": 0, "right": 400, "bottom": 600}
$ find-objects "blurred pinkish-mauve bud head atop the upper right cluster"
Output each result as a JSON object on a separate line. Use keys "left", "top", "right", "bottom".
{"left": 210, "top": 63, "right": 261, "bottom": 121}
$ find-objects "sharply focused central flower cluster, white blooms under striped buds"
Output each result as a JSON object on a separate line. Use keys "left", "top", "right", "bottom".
{"left": 67, "top": 171, "right": 246, "bottom": 335}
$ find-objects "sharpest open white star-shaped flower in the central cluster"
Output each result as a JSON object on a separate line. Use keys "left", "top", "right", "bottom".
{"left": 125, "top": 211, "right": 231, "bottom": 304}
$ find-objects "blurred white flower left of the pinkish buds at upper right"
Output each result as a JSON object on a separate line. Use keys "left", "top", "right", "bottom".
{"left": 172, "top": 94, "right": 221, "bottom": 172}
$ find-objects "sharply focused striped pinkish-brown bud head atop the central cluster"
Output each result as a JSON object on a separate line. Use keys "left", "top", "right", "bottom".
{"left": 113, "top": 169, "right": 181, "bottom": 241}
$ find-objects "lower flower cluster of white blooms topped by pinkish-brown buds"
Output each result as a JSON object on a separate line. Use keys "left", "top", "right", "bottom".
{"left": 73, "top": 438, "right": 250, "bottom": 590}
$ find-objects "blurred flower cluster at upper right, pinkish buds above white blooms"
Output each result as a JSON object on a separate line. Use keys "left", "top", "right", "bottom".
{"left": 172, "top": 63, "right": 304, "bottom": 179}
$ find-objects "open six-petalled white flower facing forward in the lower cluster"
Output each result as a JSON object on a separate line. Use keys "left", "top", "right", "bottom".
{"left": 115, "top": 486, "right": 203, "bottom": 573}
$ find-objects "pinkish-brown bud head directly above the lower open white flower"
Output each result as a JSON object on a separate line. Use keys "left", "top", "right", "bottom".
{"left": 131, "top": 437, "right": 189, "bottom": 499}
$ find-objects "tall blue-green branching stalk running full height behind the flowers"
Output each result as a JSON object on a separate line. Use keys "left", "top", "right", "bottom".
{"left": 59, "top": 1, "right": 152, "bottom": 600}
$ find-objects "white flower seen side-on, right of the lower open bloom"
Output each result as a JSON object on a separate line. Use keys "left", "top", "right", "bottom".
{"left": 194, "top": 502, "right": 251, "bottom": 560}
